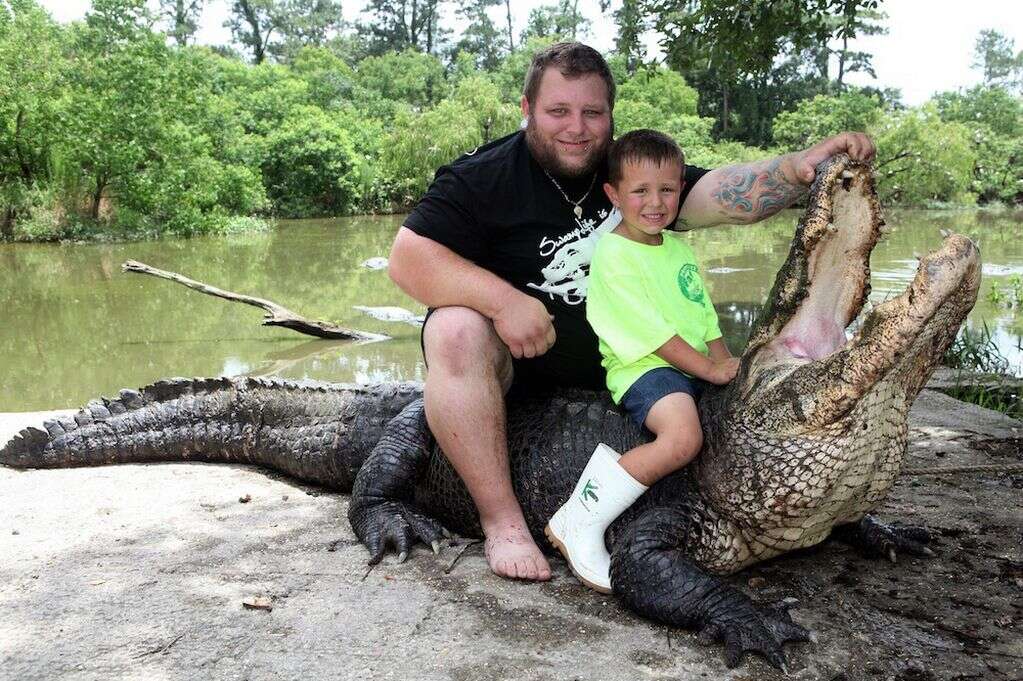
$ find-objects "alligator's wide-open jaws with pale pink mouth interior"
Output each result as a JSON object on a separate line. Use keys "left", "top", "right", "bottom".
{"left": 740, "top": 156, "right": 980, "bottom": 422}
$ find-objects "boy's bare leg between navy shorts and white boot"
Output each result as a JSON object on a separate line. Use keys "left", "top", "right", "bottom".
{"left": 618, "top": 393, "right": 703, "bottom": 487}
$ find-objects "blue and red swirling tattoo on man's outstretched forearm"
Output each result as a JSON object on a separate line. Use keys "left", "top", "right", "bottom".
{"left": 711, "top": 158, "right": 806, "bottom": 222}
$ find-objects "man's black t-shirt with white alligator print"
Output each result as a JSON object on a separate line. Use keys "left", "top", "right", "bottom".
{"left": 405, "top": 132, "right": 708, "bottom": 388}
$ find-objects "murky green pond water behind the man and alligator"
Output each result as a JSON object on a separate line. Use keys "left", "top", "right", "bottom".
{"left": 0, "top": 211, "right": 1023, "bottom": 411}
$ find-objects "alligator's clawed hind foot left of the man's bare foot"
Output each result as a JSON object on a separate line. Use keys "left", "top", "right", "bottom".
{"left": 352, "top": 501, "right": 448, "bottom": 565}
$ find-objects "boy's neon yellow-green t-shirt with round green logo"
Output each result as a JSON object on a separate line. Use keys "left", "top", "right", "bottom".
{"left": 586, "top": 231, "right": 721, "bottom": 404}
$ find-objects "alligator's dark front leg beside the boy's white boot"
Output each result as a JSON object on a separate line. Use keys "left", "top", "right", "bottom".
{"left": 611, "top": 506, "right": 810, "bottom": 670}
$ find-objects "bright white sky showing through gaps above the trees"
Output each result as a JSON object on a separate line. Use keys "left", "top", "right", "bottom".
{"left": 41, "top": 0, "right": 1023, "bottom": 106}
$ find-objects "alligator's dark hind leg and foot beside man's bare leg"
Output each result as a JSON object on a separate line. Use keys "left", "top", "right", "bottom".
{"left": 348, "top": 399, "right": 444, "bottom": 565}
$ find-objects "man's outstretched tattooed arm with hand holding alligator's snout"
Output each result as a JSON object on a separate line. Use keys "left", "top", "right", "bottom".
{"left": 678, "top": 133, "right": 875, "bottom": 229}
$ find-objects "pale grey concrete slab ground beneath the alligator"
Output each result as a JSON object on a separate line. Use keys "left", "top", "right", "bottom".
{"left": 0, "top": 392, "right": 1023, "bottom": 681}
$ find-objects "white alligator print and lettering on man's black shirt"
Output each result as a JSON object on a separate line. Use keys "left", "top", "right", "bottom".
{"left": 526, "top": 209, "right": 622, "bottom": 305}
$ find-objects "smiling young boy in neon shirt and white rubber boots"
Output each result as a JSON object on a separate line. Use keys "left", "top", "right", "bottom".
{"left": 545, "top": 130, "right": 739, "bottom": 593}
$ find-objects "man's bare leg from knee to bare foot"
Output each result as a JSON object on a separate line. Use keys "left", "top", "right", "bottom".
{"left": 422, "top": 307, "right": 550, "bottom": 580}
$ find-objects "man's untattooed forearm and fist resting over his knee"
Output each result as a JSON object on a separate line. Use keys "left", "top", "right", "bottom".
{"left": 388, "top": 227, "right": 554, "bottom": 358}
